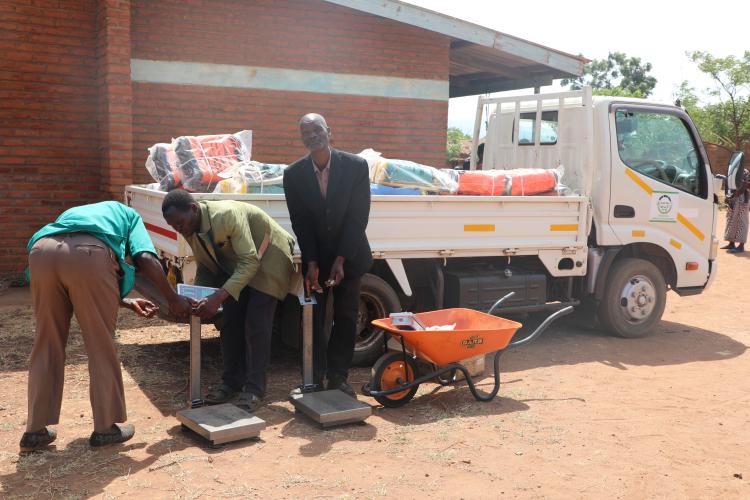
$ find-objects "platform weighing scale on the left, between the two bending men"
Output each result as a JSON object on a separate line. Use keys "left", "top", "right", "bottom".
{"left": 177, "top": 283, "right": 266, "bottom": 444}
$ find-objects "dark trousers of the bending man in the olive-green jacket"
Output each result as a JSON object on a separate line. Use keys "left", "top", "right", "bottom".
{"left": 220, "top": 286, "right": 277, "bottom": 397}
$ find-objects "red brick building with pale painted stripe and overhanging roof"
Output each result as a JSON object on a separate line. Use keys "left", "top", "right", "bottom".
{"left": 0, "top": 0, "right": 585, "bottom": 275}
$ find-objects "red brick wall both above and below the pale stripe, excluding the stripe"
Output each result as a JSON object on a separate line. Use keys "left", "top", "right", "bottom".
{"left": 132, "top": 0, "right": 449, "bottom": 182}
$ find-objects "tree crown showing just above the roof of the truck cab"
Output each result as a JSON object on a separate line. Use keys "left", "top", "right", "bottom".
{"left": 560, "top": 52, "right": 656, "bottom": 97}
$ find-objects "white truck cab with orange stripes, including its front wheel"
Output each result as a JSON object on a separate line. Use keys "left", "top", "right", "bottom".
{"left": 472, "top": 88, "right": 718, "bottom": 337}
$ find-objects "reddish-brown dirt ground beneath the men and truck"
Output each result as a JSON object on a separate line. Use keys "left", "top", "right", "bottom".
{"left": 0, "top": 221, "right": 750, "bottom": 498}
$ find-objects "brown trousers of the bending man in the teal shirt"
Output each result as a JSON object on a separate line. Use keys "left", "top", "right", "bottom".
{"left": 26, "top": 233, "right": 127, "bottom": 432}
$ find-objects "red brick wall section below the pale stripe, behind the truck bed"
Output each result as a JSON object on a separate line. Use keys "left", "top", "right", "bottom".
{"left": 133, "top": 83, "right": 448, "bottom": 183}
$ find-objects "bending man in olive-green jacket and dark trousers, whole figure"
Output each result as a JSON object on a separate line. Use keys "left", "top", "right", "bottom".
{"left": 162, "top": 189, "right": 294, "bottom": 411}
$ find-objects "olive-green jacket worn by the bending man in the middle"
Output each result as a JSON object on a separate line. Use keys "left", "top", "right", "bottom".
{"left": 187, "top": 201, "right": 294, "bottom": 300}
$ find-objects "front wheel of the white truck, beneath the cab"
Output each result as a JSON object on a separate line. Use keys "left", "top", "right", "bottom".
{"left": 598, "top": 258, "right": 667, "bottom": 338}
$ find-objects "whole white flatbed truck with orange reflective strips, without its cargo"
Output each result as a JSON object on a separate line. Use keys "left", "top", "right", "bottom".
{"left": 125, "top": 88, "right": 719, "bottom": 362}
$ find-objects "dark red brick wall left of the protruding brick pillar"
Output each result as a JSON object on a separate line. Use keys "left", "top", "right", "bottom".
{"left": 0, "top": 0, "right": 101, "bottom": 275}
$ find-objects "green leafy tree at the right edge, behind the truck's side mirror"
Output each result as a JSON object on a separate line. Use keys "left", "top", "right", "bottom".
{"left": 678, "top": 50, "right": 750, "bottom": 149}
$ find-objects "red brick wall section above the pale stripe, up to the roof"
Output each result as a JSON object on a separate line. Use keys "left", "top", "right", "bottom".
{"left": 132, "top": 0, "right": 449, "bottom": 80}
